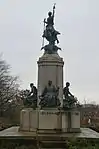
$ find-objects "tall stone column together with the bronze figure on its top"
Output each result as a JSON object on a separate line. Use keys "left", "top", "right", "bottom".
{"left": 37, "top": 5, "right": 64, "bottom": 102}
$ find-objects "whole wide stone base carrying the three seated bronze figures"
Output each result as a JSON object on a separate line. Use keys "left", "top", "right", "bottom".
{"left": 19, "top": 108, "right": 80, "bottom": 133}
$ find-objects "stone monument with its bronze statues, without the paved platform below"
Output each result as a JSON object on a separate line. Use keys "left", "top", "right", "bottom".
{"left": 20, "top": 5, "right": 80, "bottom": 133}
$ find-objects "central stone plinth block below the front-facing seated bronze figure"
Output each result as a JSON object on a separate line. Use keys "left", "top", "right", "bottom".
{"left": 39, "top": 108, "right": 62, "bottom": 130}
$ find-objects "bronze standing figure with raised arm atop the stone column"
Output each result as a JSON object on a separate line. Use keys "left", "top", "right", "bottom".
{"left": 42, "top": 5, "right": 60, "bottom": 54}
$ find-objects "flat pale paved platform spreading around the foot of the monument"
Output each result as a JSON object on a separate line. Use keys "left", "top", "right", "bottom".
{"left": 0, "top": 127, "right": 99, "bottom": 139}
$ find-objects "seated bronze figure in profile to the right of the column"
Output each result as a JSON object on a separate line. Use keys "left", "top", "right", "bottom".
{"left": 63, "top": 82, "right": 77, "bottom": 108}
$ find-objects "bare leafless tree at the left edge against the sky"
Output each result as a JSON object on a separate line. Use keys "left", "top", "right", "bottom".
{"left": 0, "top": 57, "right": 19, "bottom": 116}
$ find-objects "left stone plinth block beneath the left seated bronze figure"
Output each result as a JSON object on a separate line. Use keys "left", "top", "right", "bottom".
{"left": 20, "top": 108, "right": 38, "bottom": 131}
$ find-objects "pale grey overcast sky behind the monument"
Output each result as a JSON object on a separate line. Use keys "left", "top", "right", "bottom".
{"left": 0, "top": 0, "right": 99, "bottom": 103}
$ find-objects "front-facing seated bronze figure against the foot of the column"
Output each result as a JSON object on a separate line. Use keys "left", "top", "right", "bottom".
{"left": 40, "top": 80, "right": 60, "bottom": 107}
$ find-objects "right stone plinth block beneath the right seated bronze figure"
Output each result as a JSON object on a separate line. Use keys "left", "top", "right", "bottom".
{"left": 62, "top": 110, "right": 80, "bottom": 132}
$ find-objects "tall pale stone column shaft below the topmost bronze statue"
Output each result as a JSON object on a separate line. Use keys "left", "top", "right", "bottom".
{"left": 37, "top": 54, "right": 64, "bottom": 104}
